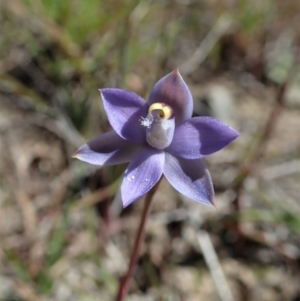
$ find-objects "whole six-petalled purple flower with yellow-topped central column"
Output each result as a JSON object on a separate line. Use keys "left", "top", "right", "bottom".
{"left": 73, "top": 69, "right": 239, "bottom": 207}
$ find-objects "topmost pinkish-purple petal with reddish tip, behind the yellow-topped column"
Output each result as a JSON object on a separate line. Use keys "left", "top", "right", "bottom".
{"left": 148, "top": 68, "right": 194, "bottom": 125}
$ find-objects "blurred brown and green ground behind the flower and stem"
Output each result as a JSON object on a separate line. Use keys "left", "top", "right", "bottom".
{"left": 0, "top": 0, "right": 300, "bottom": 301}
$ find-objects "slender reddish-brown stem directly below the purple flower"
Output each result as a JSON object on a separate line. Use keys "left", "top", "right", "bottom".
{"left": 115, "top": 180, "right": 160, "bottom": 301}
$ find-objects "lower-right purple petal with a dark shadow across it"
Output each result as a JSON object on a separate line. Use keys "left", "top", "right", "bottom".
{"left": 163, "top": 153, "right": 214, "bottom": 205}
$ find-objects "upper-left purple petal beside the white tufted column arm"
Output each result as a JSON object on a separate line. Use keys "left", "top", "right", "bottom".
{"left": 100, "top": 88, "right": 148, "bottom": 143}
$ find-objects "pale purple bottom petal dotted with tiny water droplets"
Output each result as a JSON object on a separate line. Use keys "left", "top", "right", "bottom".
{"left": 121, "top": 147, "right": 165, "bottom": 208}
